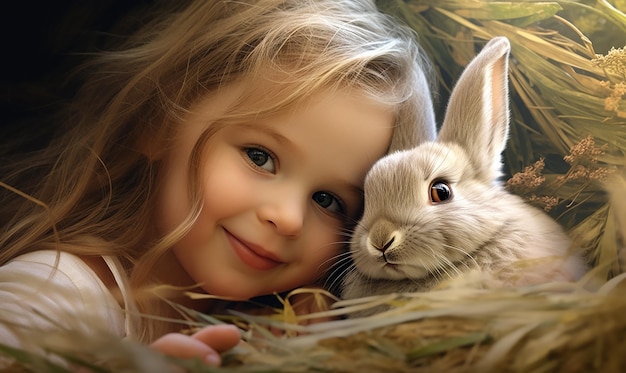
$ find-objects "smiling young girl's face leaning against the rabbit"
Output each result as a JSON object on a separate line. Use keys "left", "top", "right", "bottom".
{"left": 156, "top": 86, "right": 394, "bottom": 299}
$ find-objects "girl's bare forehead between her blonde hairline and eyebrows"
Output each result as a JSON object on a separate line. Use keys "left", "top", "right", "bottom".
{"left": 196, "top": 81, "right": 396, "bottom": 157}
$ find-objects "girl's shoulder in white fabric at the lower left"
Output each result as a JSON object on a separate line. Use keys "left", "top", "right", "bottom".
{"left": 0, "top": 250, "right": 128, "bottom": 336}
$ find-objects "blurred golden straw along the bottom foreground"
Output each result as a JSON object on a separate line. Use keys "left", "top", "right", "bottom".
{"left": 0, "top": 273, "right": 626, "bottom": 373}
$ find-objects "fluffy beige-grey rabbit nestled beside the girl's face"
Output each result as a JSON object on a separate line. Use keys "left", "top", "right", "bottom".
{"left": 340, "top": 37, "right": 586, "bottom": 310}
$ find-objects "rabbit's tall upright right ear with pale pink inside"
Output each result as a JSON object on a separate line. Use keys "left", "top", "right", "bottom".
{"left": 438, "top": 37, "right": 511, "bottom": 182}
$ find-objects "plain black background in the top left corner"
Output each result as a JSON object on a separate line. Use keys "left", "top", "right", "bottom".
{"left": 0, "top": 0, "right": 154, "bottom": 156}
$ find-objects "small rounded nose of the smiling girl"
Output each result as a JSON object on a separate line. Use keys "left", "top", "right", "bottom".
{"left": 257, "top": 193, "right": 306, "bottom": 237}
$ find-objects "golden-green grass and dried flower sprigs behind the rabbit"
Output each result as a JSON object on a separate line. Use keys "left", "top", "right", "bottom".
{"left": 378, "top": 0, "right": 626, "bottom": 278}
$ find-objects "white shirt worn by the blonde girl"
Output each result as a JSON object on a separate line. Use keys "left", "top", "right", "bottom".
{"left": 0, "top": 250, "right": 136, "bottom": 358}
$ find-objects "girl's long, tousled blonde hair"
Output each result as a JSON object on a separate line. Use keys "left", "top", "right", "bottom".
{"left": 0, "top": 0, "right": 434, "bottom": 339}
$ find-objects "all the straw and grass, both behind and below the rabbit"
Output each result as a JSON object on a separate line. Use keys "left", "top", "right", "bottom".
{"left": 0, "top": 0, "right": 626, "bottom": 372}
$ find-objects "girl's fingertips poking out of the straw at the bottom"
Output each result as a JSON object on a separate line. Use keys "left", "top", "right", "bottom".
{"left": 150, "top": 325, "right": 241, "bottom": 366}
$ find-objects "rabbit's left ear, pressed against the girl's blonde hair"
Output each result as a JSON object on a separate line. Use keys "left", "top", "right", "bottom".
{"left": 388, "top": 64, "right": 437, "bottom": 153}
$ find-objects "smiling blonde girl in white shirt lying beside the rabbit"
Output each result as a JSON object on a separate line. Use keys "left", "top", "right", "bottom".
{"left": 0, "top": 0, "right": 434, "bottom": 364}
